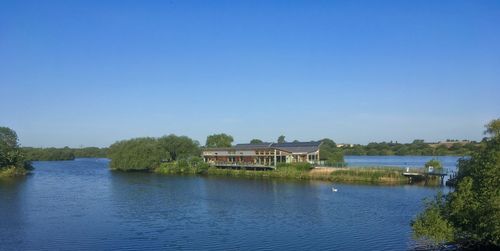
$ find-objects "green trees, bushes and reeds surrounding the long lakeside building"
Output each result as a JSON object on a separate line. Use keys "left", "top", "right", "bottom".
{"left": 108, "top": 134, "right": 440, "bottom": 184}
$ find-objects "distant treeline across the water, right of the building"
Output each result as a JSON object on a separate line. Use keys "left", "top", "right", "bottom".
{"left": 342, "top": 140, "right": 481, "bottom": 156}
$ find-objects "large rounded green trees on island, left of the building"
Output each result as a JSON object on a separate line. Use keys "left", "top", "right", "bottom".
{"left": 108, "top": 134, "right": 200, "bottom": 171}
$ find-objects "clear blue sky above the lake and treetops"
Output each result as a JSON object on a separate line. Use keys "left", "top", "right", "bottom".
{"left": 0, "top": 0, "right": 500, "bottom": 147}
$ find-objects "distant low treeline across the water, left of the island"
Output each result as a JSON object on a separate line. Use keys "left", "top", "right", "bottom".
{"left": 22, "top": 147, "right": 107, "bottom": 161}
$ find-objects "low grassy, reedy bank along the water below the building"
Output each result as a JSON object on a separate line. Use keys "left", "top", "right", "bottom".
{"left": 154, "top": 162, "right": 437, "bottom": 185}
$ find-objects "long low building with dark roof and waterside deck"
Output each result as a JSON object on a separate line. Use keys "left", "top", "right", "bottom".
{"left": 202, "top": 141, "right": 321, "bottom": 166}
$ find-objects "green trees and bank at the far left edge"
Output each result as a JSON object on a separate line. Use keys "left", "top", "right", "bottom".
{"left": 0, "top": 127, "right": 32, "bottom": 177}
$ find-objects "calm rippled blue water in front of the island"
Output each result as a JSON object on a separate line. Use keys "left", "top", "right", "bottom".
{"left": 0, "top": 159, "right": 454, "bottom": 250}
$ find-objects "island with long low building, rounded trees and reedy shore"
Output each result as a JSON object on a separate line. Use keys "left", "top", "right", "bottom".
{"left": 108, "top": 133, "right": 440, "bottom": 185}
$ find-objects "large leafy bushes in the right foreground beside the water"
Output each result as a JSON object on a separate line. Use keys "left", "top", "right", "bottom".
{"left": 412, "top": 119, "right": 500, "bottom": 250}
